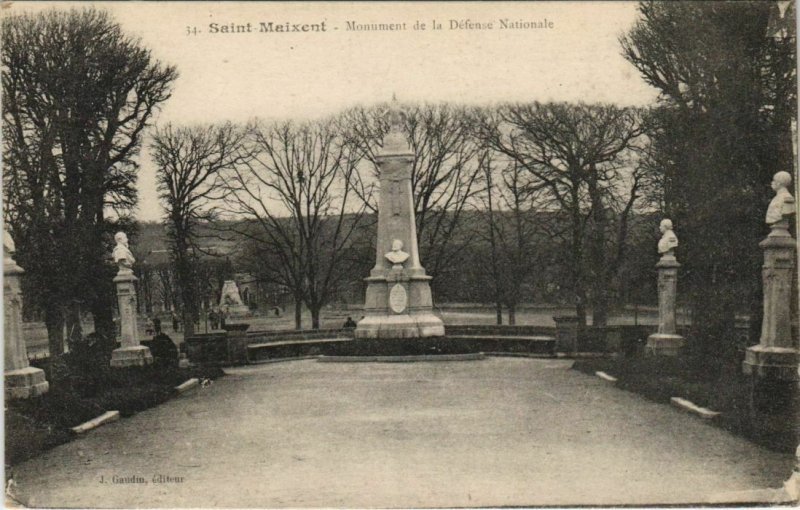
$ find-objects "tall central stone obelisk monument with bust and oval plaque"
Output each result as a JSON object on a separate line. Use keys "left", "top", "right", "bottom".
{"left": 355, "top": 102, "right": 444, "bottom": 339}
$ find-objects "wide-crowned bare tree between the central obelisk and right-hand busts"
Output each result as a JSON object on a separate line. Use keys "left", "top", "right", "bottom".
{"left": 477, "top": 103, "right": 645, "bottom": 326}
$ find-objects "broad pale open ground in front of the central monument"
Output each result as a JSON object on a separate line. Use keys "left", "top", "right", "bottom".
{"left": 7, "top": 358, "right": 793, "bottom": 507}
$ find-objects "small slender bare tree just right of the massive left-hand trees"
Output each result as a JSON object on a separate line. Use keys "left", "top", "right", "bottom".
{"left": 151, "top": 123, "right": 250, "bottom": 337}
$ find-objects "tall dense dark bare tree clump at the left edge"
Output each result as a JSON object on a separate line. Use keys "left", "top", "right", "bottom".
{"left": 2, "top": 9, "right": 177, "bottom": 355}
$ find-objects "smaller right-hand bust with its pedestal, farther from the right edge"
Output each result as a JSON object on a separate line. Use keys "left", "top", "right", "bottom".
{"left": 645, "top": 219, "right": 684, "bottom": 356}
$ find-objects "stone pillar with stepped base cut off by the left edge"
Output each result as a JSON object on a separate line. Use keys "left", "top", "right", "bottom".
{"left": 3, "top": 246, "right": 50, "bottom": 398}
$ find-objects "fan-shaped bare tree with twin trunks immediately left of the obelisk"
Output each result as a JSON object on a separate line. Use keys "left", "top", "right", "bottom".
{"left": 222, "top": 120, "right": 366, "bottom": 329}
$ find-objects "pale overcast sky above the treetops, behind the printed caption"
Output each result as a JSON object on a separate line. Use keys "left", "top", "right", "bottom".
{"left": 10, "top": 2, "right": 656, "bottom": 220}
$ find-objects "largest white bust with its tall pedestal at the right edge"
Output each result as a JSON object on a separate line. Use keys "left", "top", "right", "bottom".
{"left": 742, "top": 172, "right": 800, "bottom": 381}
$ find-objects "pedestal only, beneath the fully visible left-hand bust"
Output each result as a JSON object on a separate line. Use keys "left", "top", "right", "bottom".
{"left": 111, "top": 268, "right": 153, "bottom": 367}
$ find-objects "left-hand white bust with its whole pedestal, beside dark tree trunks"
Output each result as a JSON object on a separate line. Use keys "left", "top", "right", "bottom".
{"left": 111, "top": 232, "right": 153, "bottom": 367}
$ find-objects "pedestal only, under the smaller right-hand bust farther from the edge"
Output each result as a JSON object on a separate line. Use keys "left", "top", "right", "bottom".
{"left": 644, "top": 250, "right": 685, "bottom": 356}
